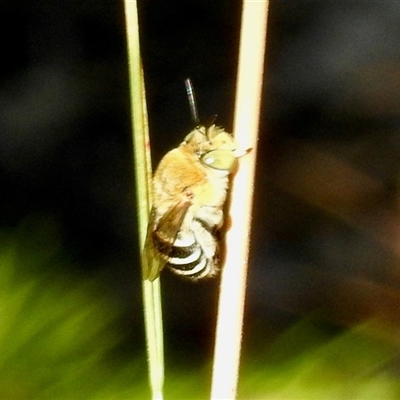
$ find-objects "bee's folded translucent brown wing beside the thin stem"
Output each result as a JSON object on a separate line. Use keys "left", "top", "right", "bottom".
{"left": 142, "top": 201, "right": 191, "bottom": 281}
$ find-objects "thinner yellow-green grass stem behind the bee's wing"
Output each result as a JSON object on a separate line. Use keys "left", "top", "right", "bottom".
{"left": 125, "top": 0, "right": 164, "bottom": 400}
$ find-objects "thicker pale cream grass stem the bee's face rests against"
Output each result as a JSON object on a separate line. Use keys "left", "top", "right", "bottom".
{"left": 211, "top": 0, "right": 269, "bottom": 399}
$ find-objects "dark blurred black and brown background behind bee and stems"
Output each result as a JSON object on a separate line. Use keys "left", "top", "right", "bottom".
{"left": 0, "top": 0, "right": 400, "bottom": 394}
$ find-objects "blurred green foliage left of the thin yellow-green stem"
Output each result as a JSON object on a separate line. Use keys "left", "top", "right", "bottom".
{"left": 0, "top": 218, "right": 147, "bottom": 400}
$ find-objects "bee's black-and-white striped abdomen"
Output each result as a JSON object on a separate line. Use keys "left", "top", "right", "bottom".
{"left": 153, "top": 221, "right": 217, "bottom": 280}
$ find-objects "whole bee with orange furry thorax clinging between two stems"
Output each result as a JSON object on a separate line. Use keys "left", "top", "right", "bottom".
{"left": 143, "top": 81, "right": 243, "bottom": 281}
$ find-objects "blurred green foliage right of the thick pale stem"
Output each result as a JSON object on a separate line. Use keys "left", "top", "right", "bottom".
{"left": 239, "top": 320, "right": 400, "bottom": 400}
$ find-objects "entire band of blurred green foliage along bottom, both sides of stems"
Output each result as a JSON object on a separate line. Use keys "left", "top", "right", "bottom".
{"left": 0, "top": 218, "right": 400, "bottom": 400}
